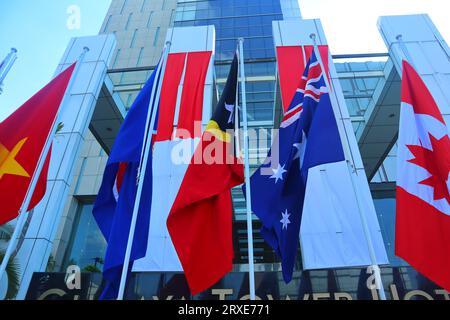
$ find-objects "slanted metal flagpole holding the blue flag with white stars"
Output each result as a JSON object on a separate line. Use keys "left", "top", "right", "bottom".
{"left": 310, "top": 33, "right": 386, "bottom": 300}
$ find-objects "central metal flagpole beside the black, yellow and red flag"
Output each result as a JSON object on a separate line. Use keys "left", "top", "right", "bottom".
{"left": 239, "top": 38, "right": 256, "bottom": 300}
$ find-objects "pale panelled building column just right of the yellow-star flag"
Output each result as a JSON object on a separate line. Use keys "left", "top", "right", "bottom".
{"left": 17, "top": 35, "right": 116, "bottom": 299}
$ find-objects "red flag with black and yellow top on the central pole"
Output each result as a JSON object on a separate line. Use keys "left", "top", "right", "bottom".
{"left": 167, "top": 55, "right": 244, "bottom": 295}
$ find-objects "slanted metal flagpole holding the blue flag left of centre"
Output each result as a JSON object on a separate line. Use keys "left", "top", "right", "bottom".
{"left": 117, "top": 42, "right": 171, "bottom": 300}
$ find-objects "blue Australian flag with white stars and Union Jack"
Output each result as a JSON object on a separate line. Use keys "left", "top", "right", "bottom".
{"left": 244, "top": 53, "right": 345, "bottom": 283}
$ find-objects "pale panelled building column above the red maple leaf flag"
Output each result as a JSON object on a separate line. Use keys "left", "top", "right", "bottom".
{"left": 378, "top": 14, "right": 450, "bottom": 126}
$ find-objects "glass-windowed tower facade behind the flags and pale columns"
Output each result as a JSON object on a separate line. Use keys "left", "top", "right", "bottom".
{"left": 28, "top": 0, "right": 444, "bottom": 299}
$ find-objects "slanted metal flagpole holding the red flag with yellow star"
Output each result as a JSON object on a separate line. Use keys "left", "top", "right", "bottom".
{"left": 0, "top": 47, "right": 89, "bottom": 290}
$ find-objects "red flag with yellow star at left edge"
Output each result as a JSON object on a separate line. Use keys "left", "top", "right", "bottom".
{"left": 0, "top": 64, "right": 75, "bottom": 225}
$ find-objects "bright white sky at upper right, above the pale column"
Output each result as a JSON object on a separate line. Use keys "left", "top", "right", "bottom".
{"left": 299, "top": 0, "right": 450, "bottom": 54}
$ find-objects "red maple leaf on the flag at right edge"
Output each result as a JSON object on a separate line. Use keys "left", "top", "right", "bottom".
{"left": 407, "top": 134, "right": 450, "bottom": 204}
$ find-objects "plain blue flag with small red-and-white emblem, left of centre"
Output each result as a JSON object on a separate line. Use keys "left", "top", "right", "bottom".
{"left": 93, "top": 63, "right": 159, "bottom": 300}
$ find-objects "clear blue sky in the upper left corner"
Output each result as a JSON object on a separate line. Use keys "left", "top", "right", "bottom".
{"left": 0, "top": 0, "right": 111, "bottom": 121}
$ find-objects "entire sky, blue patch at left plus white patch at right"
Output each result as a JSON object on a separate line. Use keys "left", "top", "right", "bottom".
{"left": 0, "top": 0, "right": 450, "bottom": 121}
